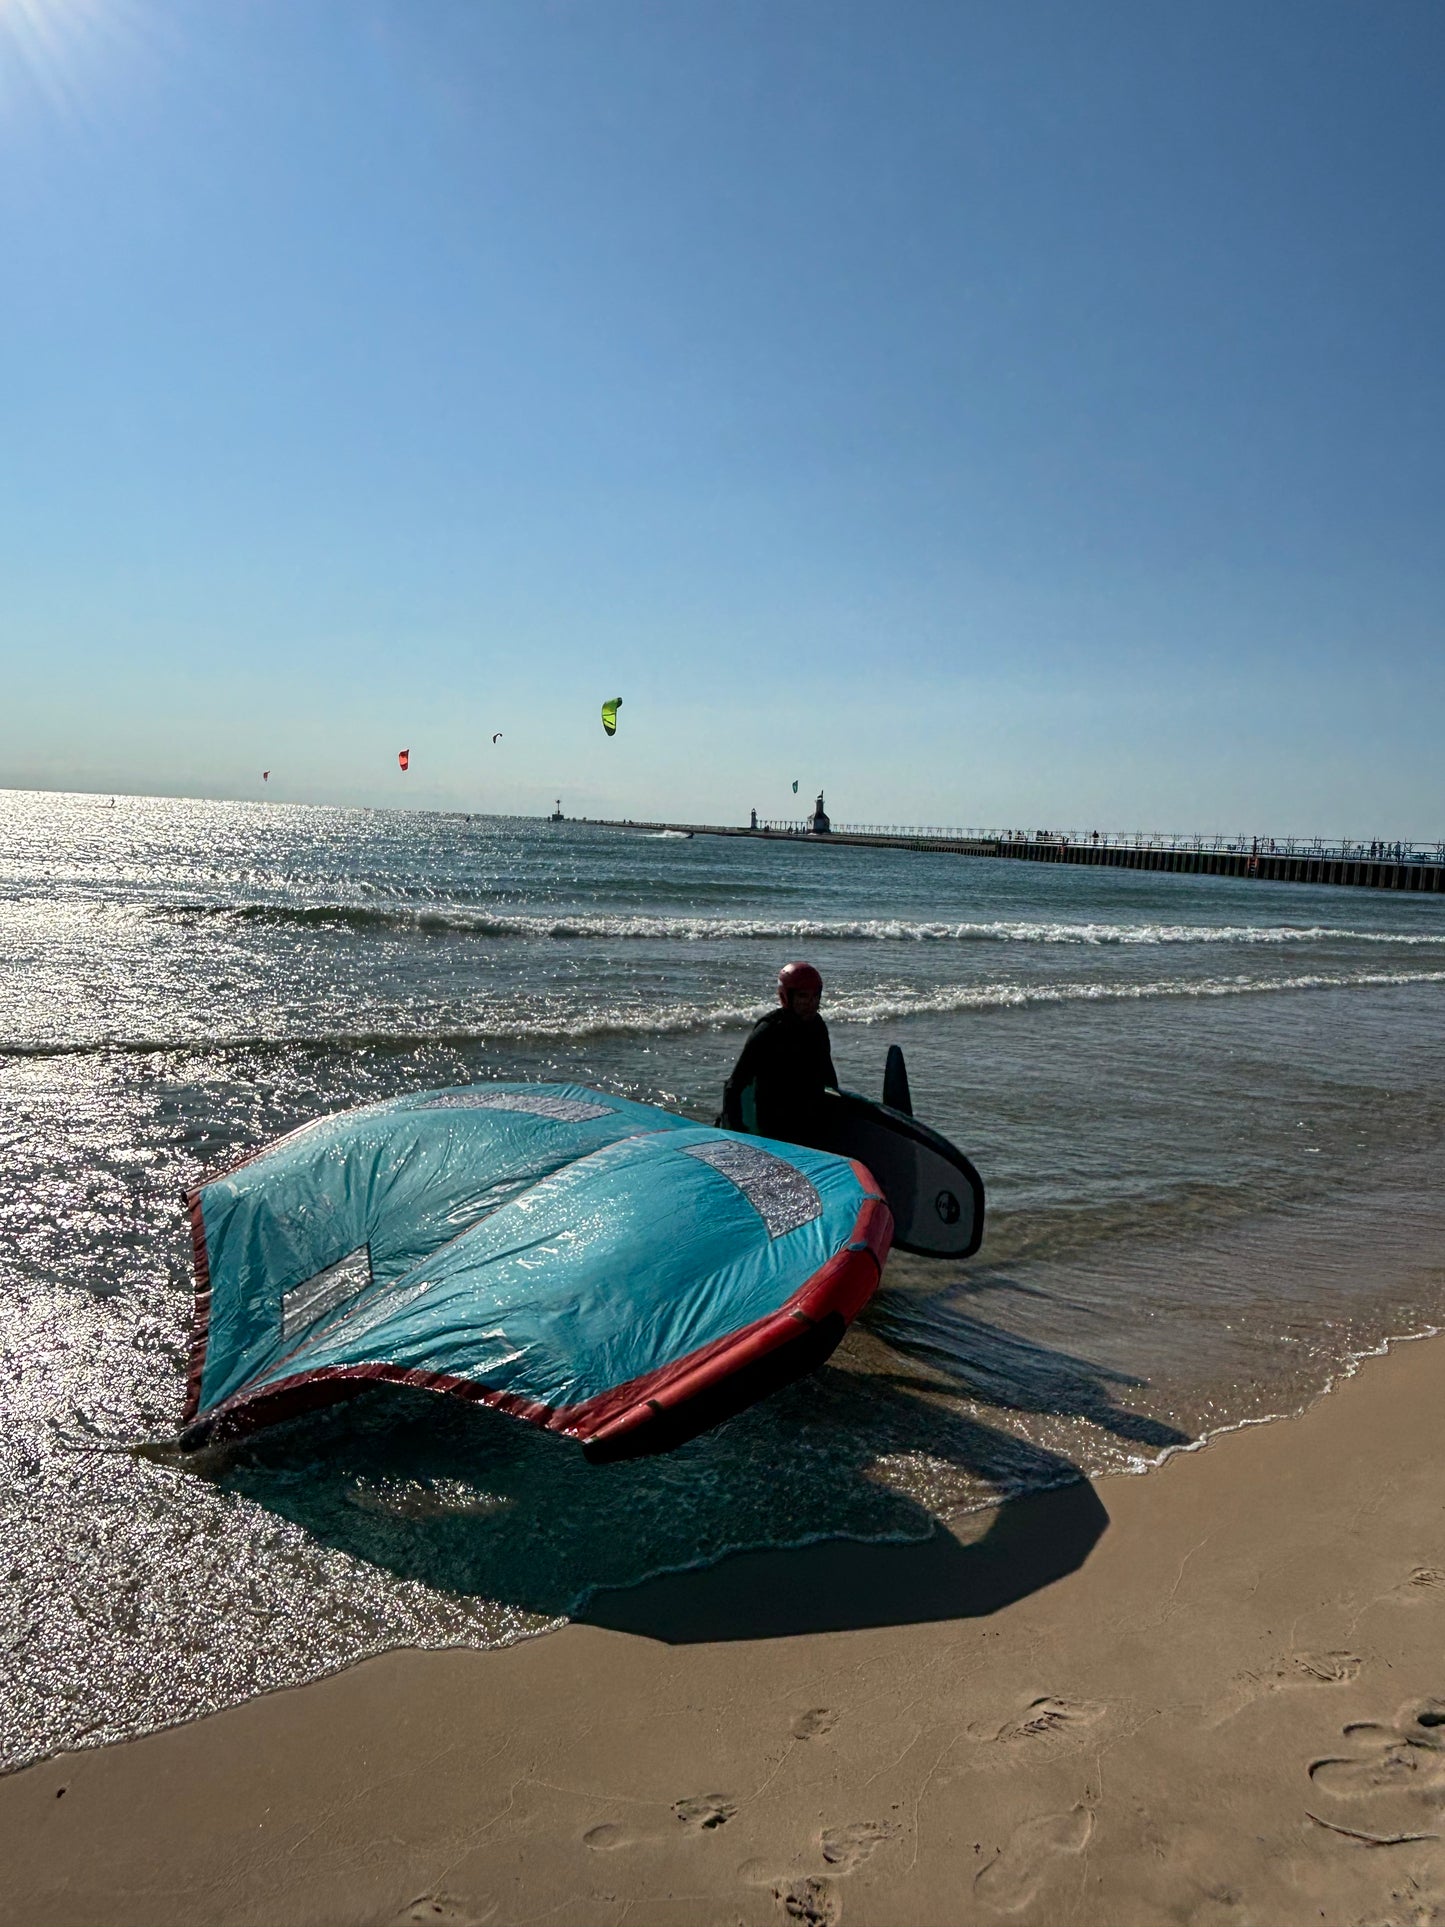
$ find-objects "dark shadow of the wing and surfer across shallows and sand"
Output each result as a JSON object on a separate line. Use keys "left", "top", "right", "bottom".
{"left": 195, "top": 1301, "right": 1183, "bottom": 1642}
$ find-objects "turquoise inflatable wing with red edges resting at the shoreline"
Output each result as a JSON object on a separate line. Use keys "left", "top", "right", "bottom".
{"left": 183, "top": 1083, "right": 892, "bottom": 1461}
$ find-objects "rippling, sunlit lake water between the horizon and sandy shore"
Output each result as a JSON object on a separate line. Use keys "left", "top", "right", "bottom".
{"left": 0, "top": 794, "right": 1445, "bottom": 1765}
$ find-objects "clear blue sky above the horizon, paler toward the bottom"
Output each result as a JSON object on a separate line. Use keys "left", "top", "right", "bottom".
{"left": 0, "top": 0, "right": 1445, "bottom": 838}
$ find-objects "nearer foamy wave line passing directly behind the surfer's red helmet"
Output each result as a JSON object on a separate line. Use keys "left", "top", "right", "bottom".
{"left": 11, "top": 969, "right": 1445, "bottom": 1058}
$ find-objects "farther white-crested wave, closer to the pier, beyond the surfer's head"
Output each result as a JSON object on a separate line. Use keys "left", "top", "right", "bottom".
{"left": 164, "top": 904, "right": 1445, "bottom": 948}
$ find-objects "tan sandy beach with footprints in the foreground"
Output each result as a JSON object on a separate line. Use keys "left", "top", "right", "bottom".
{"left": 0, "top": 1339, "right": 1445, "bottom": 1927}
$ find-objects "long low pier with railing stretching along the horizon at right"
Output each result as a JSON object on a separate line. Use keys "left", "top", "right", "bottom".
{"left": 578, "top": 820, "right": 1445, "bottom": 894}
